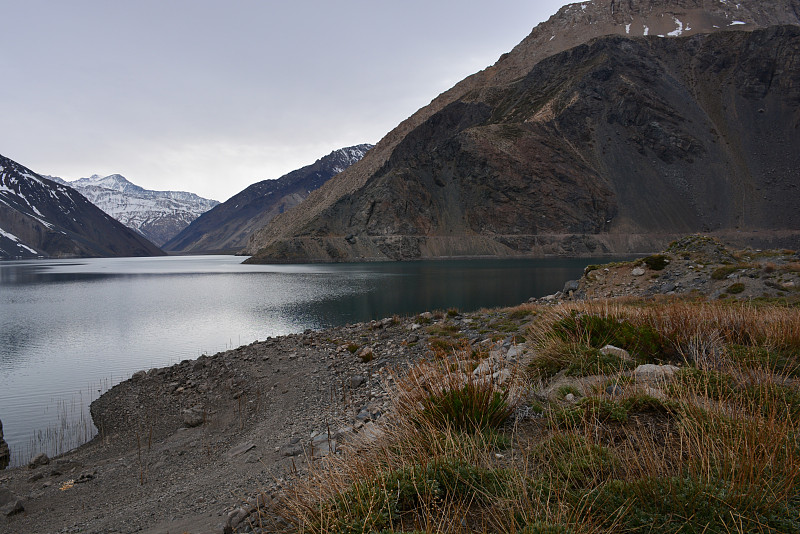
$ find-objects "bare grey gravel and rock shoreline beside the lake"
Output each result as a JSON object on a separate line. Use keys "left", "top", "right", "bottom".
{"left": 0, "top": 236, "right": 800, "bottom": 533}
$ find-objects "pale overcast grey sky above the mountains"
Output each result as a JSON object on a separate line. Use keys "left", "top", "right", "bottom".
{"left": 0, "top": 0, "right": 567, "bottom": 201}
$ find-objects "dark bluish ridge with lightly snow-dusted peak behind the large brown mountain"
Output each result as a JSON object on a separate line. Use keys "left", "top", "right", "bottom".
{"left": 164, "top": 144, "right": 372, "bottom": 252}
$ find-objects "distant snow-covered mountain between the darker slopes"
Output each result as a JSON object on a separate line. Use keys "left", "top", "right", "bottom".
{"left": 48, "top": 174, "right": 219, "bottom": 246}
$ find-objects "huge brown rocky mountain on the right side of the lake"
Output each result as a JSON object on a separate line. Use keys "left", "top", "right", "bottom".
{"left": 244, "top": 0, "right": 800, "bottom": 262}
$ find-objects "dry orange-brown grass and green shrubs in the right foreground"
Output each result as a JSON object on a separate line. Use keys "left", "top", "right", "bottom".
{"left": 264, "top": 297, "right": 800, "bottom": 534}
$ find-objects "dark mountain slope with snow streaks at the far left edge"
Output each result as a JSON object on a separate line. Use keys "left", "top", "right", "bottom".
{"left": 0, "top": 155, "right": 164, "bottom": 259}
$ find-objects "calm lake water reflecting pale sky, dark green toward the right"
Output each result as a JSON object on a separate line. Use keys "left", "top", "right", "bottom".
{"left": 0, "top": 256, "right": 608, "bottom": 463}
